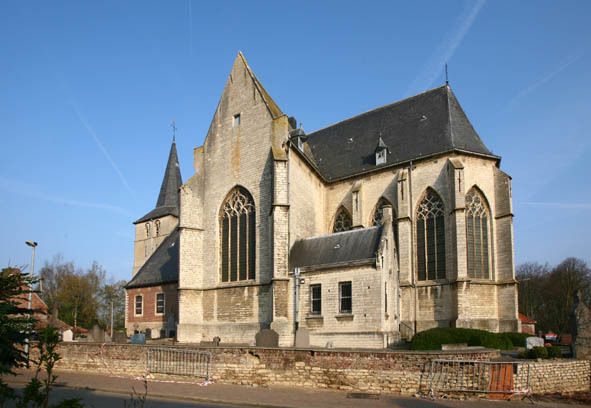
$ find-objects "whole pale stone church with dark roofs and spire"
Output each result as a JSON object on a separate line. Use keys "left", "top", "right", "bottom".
{"left": 126, "top": 53, "right": 519, "bottom": 348}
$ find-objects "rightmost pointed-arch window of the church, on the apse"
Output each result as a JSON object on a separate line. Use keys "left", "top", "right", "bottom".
{"left": 466, "top": 187, "right": 490, "bottom": 279}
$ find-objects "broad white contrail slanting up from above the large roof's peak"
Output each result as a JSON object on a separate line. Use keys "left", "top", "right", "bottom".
{"left": 407, "top": 0, "right": 486, "bottom": 95}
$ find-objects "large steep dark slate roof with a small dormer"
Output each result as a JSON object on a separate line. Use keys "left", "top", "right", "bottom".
{"left": 304, "top": 85, "right": 498, "bottom": 181}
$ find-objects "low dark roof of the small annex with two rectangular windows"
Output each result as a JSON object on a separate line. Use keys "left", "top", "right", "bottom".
{"left": 289, "top": 227, "right": 382, "bottom": 269}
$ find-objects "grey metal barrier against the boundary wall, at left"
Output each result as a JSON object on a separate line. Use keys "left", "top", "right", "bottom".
{"left": 146, "top": 347, "right": 211, "bottom": 380}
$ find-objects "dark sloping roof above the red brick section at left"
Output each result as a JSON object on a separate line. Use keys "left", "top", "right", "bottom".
{"left": 125, "top": 229, "right": 180, "bottom": 289}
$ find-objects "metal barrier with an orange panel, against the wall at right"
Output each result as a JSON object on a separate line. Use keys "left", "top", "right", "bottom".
{"left": 429, "top": 360, "right": 530, "bottom": 399}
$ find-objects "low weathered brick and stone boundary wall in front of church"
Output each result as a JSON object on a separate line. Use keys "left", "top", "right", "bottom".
{"left": 34, "top": 343, "right": 591, "bottom": 395}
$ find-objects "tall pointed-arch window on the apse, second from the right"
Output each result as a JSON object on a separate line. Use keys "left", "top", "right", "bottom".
{"left": 416, "top": 189, "right": 445, "bottom": 281}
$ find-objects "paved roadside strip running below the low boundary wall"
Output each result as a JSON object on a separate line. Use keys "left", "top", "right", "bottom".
{"left": 6, "top": 370, "right": 584, "bottom": 408}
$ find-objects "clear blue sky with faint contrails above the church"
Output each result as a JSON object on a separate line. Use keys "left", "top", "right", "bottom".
{"left": 0, "top": 0, "right": 591, "bottom": 279}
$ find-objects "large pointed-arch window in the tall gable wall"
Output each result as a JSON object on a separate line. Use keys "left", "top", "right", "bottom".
{"left": 220, "top": 187, "right": 256, "bottom": 282}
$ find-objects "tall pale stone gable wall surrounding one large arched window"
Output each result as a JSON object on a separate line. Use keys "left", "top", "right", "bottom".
{"left": 179, "top": 57, "right": 287, "bottom": 342}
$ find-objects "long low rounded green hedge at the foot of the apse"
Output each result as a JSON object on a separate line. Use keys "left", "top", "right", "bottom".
{"left": 411, "top": 327, "right": 525, "bottom": 350}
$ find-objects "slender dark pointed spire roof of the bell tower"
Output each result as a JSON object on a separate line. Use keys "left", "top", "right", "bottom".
{"left": 134, "top": 140, "right": 183, "bottom": 224}
